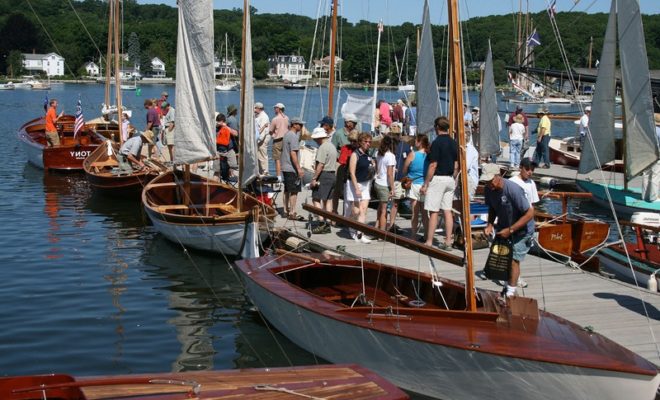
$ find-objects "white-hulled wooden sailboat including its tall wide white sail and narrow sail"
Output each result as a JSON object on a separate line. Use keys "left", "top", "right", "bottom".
{"left": 142, "top": 0, "right": 277, "bottom": 256}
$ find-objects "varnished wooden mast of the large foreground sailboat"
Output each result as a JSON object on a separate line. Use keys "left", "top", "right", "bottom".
{"left": 447, "top": 0, "right": 477, "bottom": 311}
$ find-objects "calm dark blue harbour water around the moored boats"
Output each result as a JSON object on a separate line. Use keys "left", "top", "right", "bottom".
{"left": 0, "top": 84, "right": 604, "bottom": 396}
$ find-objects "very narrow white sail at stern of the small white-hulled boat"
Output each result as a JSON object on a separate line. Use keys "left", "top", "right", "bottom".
{"left": 240, "top": 1, "right": 259, "bottom": 187}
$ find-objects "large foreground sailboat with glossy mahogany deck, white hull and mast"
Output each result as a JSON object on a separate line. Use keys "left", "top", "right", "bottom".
{"left": 235, "top": 0, "right": 660, "bottom": 399}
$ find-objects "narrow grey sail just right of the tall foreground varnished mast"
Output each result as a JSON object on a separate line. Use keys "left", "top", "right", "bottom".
{"left": 479, "top": 40, "right": 500, "bottom": 157}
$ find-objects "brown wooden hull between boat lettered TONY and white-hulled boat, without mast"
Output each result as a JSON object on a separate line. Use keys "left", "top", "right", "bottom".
{"left": 83, "top": 141, "right": 167, "bottom": 197}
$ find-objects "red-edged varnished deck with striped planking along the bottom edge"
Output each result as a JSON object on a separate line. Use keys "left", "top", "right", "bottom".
{"left": 0, "top": 365, "right": 408, "bottom": 400}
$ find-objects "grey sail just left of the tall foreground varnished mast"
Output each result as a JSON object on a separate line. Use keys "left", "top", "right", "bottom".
{"left": 415, "top": 0, "right": 441, "bottom": 133}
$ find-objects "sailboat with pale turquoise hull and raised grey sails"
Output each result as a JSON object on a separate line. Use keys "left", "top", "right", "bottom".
{"left": 577, "top": 0, "right": 660, "bottom": 214}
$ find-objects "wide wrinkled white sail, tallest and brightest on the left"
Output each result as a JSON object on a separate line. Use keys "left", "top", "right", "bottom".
{"left": 174, "top": 0, "right": 216, "bottom": 164}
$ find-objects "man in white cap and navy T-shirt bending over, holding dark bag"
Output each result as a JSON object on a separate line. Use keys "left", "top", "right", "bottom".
{"left": 480, "top": 164, "right": 534, "bottom": 303}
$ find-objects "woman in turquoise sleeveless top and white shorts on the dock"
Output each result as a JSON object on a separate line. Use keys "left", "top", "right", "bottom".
{"left": 403, "top": 135, "right": 429, "bottom": 239}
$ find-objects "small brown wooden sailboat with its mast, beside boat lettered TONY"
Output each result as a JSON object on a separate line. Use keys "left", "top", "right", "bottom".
{"left": 83, "top": 0, "right": 167, "bottom": 196}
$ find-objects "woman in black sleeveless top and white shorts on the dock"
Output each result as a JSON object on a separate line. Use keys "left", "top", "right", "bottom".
{"left": 344, "top": 133, "right": 373, "bottom": 243}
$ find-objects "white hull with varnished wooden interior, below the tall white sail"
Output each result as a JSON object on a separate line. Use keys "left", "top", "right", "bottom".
{"left": 142, "top": 171, "right": 277, "bottom": 256}
